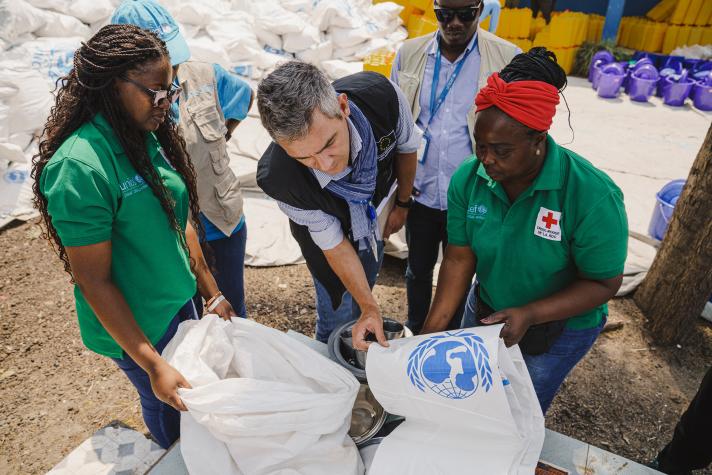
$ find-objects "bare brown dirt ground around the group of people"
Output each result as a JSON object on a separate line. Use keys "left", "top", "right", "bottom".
{"left": 0, "top": 220, "right": 712, "bottom": 475}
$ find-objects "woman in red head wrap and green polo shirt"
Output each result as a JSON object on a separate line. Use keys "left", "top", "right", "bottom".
{"left": 423, "top": 48, "right": 628, "bottom": 412}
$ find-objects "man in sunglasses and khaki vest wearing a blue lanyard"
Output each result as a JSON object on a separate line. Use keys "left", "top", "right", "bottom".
{"left": 391, "top": 0, "right": 521, "bottom": 333}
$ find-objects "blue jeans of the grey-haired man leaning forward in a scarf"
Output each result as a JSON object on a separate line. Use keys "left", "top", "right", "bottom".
{"left": 312, "top": 241, "right": 383, "bottom": 343}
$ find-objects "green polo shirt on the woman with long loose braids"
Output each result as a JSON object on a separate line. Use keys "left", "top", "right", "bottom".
{"left": 40, "top": 115, "right": 196, "bottom": 358}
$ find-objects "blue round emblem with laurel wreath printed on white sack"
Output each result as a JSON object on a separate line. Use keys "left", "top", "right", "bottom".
{"left": 407, "top": 330, "right": 492, "bottom": 399}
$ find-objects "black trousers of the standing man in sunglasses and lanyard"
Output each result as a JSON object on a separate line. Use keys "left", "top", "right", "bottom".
{"left": 405, "top": 202, "right": 466, "bottom": 335}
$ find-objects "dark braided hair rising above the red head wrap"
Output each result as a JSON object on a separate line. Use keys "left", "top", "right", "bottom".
{"left": 499, "top": 46, "right": 575, "bottom": 145}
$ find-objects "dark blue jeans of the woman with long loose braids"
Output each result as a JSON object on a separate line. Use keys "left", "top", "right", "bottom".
{"left": 111, "top": 299, "right": 198, "bottom": 449}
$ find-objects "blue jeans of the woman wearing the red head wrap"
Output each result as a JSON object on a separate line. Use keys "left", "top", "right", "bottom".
{"left": 462, "top": 285, "right": 606, "bottom": 414}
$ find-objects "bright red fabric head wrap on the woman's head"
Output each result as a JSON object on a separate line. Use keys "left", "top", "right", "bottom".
{"left": 475, "top": 73, "right": 559, "bottom": 132}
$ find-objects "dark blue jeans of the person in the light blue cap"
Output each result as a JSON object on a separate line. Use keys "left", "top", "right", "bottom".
{"left": 195, "top": 223, "right": 247, "bottom": 318}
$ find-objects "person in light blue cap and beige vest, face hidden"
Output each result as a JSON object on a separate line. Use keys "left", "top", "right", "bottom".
{"left": 111, "top": 0, "right": 254, "bottom": 318}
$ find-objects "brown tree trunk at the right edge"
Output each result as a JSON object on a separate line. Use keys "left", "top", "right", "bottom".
{"left": 634, "top": 122, "right": 712, "bottom": 345}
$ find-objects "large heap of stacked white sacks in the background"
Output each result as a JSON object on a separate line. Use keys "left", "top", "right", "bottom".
{"left": 0, "top": 0, "right": 407, "bottom": 229}
